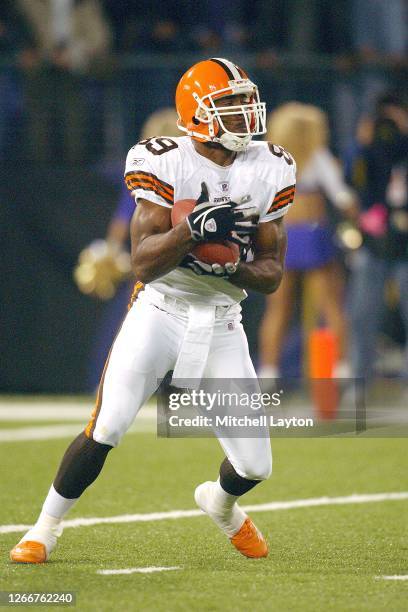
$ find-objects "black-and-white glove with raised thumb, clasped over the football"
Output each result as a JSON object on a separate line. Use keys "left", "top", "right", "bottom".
{"left": 186, "top": 183, "right": 259, "bottom": 245}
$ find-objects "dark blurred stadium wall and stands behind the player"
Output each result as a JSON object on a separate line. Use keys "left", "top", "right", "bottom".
{"left": 0, "top": 0, "right": 408, "bottom": 393}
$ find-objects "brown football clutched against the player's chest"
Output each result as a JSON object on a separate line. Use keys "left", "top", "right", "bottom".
{"left": 171, "top": 199, "right": 239, "bottom": 266}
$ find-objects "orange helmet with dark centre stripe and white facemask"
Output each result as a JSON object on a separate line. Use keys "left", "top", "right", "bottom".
{"left": 176, "top": 57, "right": 266, "bottom": 151}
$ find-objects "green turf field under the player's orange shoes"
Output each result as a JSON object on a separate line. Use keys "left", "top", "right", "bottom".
{"left": 0, "top": 402, "right": 408, "bottom": 611}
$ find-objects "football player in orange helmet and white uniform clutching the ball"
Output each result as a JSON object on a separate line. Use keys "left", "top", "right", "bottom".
{"left": 11, "top": 58, "right": 295, "bottom": 563}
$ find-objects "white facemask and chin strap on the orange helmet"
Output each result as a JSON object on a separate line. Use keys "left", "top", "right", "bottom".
{"left": 179, "top": 79, "right": 266, "bottom": 151}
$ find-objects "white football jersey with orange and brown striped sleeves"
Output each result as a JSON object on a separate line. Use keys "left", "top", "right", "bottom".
{"left": 125, "top": 136, "right": 296, "bottom": 305}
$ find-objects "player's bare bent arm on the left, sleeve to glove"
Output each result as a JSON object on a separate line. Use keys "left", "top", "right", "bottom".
{"left": 130, "top": 199, "right": 195, "bottom": 283}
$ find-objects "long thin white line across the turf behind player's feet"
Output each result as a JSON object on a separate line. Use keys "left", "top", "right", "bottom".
{"left": 0, "top": 491, "right": 408, "bottom": 534}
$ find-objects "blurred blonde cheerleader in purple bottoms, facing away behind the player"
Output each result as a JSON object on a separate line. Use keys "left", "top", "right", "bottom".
{"left": 258, "top": 102, "right": 355, "bottom": 378}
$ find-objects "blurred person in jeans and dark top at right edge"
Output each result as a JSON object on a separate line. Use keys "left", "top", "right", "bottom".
{"left": 350, "top": 94, "right": 408, "bottom": 378}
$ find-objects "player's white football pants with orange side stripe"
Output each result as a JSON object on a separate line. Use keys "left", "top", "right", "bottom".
{"left": 90, "top": 287, "right": 272, "bottom": 480}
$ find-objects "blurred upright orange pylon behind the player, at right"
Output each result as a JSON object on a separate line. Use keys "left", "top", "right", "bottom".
{"left": 308, "top": 328, "right": 340, "bottom": 420}
